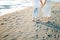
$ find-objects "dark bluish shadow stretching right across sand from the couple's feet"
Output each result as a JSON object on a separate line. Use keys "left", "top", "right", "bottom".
{"left": 36, "top": 21, "right": 60, "bottom": 30}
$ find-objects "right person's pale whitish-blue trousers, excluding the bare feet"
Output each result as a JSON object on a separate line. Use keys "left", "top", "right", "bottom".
{"left": 42, "top": 3, "right": 51, "bottom": 17}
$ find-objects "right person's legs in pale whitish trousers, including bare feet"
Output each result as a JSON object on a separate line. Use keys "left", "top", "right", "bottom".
{"left": 43, "top": 3, "right": 51, "bottom": 22}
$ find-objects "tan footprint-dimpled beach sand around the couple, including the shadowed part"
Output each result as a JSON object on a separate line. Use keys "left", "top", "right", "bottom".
{"left": 0, "top": 3, "right": 60, "bottom": 40}
